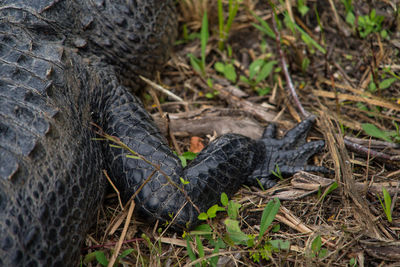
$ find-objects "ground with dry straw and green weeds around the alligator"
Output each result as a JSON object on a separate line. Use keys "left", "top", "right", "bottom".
{"left": 82, "top": 0, "right": 400, "bottom": 266}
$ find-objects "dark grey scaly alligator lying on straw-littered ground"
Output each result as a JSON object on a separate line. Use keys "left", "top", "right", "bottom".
{"left": 0, "top": 0, "right": 325, "bottom": 266}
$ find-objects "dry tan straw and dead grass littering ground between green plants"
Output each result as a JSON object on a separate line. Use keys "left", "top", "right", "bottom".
{"left": 84, "top": 0, "right": 400, "bottom": 266}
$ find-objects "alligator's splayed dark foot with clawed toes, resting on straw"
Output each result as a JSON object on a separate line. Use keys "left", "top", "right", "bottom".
{"left": 249, "top": 116, "right": 329, "bottom": 188}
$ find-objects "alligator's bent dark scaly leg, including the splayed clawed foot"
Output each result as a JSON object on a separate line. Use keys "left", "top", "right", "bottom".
{"left": 101, "top": 82, "right": 325, "bottom": 229}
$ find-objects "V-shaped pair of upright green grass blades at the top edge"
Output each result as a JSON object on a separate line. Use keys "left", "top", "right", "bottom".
{"left": 218, "top": 0, "right": 241, "bottom": 51}
